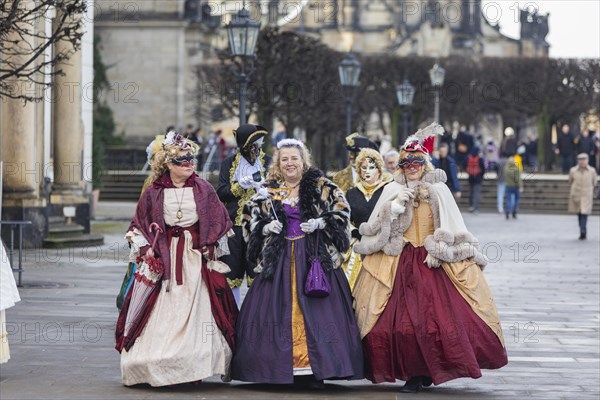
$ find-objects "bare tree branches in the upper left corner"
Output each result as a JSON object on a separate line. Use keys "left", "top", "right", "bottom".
{"left": 0, "top": 0, "right": 87, "bottom": 102}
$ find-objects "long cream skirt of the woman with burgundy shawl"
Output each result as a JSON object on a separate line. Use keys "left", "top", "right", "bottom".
{"left": 121, "top": 231, "right": 232, "bottom": 386}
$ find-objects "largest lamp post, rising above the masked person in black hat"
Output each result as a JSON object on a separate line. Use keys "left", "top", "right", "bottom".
{"left": 227, "top": 8, "right": 260, "bottom": 125}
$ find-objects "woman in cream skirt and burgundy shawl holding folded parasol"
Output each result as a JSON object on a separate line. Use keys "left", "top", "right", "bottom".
{"left": 116, "top": 131, "right": 237, "bottom": 386}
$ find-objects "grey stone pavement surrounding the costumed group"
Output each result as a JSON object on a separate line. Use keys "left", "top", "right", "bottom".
{"left": 0, "top": 203, "right": 600, "bottom": 400}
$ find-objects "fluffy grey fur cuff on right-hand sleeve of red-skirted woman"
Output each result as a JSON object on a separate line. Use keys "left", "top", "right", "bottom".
{"left": 425, "top": 229, "right": 488, "bottom": 269}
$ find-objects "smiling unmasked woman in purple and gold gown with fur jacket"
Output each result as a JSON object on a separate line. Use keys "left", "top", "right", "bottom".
{"left": 232, "top": 139, "right": 363, "bottom": 388}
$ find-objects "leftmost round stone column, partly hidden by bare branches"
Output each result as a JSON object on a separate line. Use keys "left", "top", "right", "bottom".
{"left": 0, "top": 0, "right": 47, "bottom": 247}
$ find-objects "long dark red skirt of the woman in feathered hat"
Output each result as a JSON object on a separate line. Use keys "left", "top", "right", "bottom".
{"left": 363, "top": 243, "right": 508, "bottom": 385}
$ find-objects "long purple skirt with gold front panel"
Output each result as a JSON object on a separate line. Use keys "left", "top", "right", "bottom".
{"left": 232, "top": 238, "right": 364, "bottom": 384}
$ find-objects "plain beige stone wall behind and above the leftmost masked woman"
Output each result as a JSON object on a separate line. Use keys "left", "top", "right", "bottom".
{"left": 95, "top": 0, "right": 227, "bottom": 141}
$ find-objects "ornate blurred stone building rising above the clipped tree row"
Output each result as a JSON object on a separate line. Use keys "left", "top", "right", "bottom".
{"left": 264, "top": 0, "right": 549, "bottom": 58}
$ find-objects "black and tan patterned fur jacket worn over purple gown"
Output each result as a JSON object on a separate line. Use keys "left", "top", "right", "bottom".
{"left": 242, "top": 168, "right": 350, "bottom": 278}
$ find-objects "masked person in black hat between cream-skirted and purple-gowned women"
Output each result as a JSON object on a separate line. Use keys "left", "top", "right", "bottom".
{"left": 217, "top": 124, "right": 271, "bottom": 305}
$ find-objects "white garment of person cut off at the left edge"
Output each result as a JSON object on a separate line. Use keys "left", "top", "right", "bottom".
{"left": 0, "top": 242, "right": 21, "bottom": 364}
